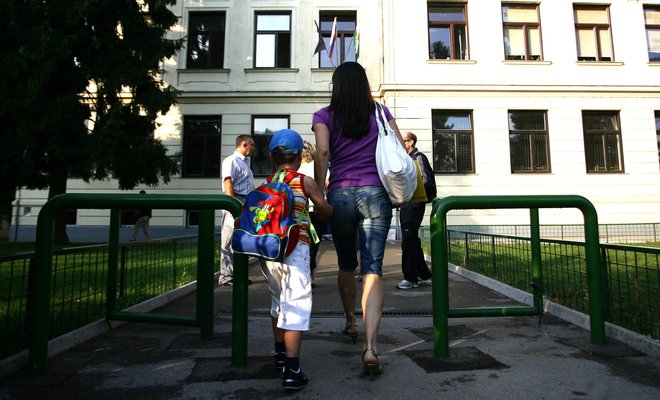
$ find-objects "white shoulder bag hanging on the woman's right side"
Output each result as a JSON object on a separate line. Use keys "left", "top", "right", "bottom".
{"left": 376, "top": 102, "right": 417, "bottom": 205}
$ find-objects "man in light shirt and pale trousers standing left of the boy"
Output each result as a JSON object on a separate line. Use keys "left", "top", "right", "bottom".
{"left": 218, "top": 135, "right": 254, "bottom": 285}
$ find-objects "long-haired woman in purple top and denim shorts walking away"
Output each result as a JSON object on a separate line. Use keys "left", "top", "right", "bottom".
{"left": 312, "top": 62, "right": 403, "bottom": 375}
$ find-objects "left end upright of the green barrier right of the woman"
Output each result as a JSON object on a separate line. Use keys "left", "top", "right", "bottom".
{"left": 431, "top": 199, "right": 449, "bottom": 358}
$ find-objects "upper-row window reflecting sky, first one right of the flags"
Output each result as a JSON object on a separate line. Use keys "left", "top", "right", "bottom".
{"left": 428, "top": 3, "right": 468, "bottom": 60}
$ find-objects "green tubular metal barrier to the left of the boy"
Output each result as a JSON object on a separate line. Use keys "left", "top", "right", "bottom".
{"left": 28, "top": 194, "right": 248, "bottom": 372}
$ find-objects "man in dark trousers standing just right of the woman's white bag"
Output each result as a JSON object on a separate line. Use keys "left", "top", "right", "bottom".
{"left": 396, "top": 132, "right": 436, "bottom": 290}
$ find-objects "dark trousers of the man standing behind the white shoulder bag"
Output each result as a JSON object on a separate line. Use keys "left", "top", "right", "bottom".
{"left": 399, "top": 203, "right": 431, "bottom": 283}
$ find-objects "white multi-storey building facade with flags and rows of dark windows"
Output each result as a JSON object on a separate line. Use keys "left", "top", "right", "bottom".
{"left": 10, "top": 0, "right": 660, "bottom": 241}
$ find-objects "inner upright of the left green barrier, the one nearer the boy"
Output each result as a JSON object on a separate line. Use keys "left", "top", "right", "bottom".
{"left": 197, "top": 210, "right": 215, "bottom": 338}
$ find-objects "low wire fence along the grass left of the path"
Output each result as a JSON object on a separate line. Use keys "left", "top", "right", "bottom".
{"left": 0, "top": 236, "right": 206, "bottom": 359}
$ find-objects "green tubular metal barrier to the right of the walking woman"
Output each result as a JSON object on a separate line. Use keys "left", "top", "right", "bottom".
{"left": 431, "top": 195, "right": 605, "bottom": 357}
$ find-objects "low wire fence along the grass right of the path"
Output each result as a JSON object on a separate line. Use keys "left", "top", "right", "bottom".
{"left": 440, "top": 229, "right": 660, "bottom": 340}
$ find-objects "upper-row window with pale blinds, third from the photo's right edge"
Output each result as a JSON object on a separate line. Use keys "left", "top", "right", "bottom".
{"left": 502, "top": 4, "right": 543, "bottom": 60}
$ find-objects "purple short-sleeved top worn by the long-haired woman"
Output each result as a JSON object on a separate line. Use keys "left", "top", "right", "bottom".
{"left": 312, "top": 106, "right": 394, "bottom": 192}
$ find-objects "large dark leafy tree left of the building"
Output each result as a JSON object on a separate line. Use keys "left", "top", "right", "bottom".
{"left": 0, "top": 0, "right": 182, "bottom": 242}
